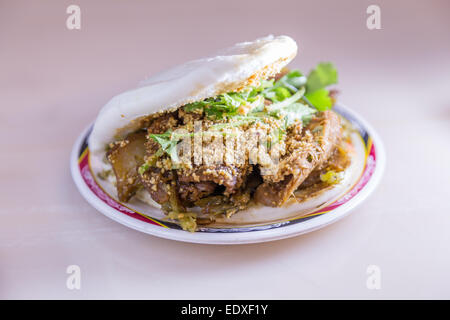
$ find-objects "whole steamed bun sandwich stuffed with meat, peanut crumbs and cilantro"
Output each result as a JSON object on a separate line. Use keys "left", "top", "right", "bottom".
{"left": 89, "top": 36, "right": 351, "bottom": 231}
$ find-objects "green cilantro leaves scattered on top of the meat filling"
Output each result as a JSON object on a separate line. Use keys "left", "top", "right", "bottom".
{"left": 149, "top": 62, "right": 338, "bottom": 162}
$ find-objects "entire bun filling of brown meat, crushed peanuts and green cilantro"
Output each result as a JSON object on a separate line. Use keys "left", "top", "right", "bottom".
{"left": 102, "top": 63, "right": 350, "bottom": 231}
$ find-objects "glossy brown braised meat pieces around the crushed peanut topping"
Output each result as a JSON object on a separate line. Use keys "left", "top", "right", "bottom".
{"left": 107, "top": 102, "right": 348, "bottom": 216}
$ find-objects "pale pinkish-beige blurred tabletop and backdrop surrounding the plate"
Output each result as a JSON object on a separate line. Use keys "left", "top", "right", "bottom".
{"left": 0, "top": 0, "right": 450, "bottom": 299}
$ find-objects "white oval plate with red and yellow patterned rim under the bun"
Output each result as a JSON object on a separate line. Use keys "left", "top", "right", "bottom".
{"left": 70, "top": 105, "right": 386, "bottom": 244}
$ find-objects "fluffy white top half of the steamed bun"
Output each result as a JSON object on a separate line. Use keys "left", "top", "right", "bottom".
{"left": 89, "top": 35, "right": 297, "bottom": 154}
